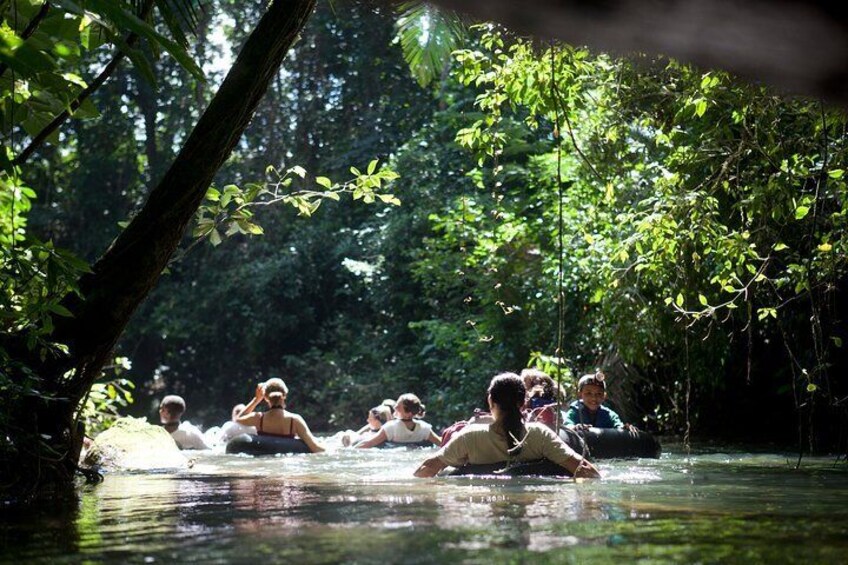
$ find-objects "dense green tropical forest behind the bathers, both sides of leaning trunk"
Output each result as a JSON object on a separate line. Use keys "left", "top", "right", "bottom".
{"left": 0, "top": 0, "right": 848, "bottom": 462}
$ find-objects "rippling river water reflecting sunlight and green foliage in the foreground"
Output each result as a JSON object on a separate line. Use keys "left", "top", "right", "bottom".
{"left": 0, "top": 446, "right": 848, "bottom": 565}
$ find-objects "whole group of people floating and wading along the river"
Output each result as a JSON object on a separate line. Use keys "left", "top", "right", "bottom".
{"left": 159, "top": 369, "right": 629, "bottom": 477}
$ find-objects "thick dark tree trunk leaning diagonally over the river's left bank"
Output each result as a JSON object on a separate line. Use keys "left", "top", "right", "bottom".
{"left": 29, "top": 0, "right": 315, "bottom": 490}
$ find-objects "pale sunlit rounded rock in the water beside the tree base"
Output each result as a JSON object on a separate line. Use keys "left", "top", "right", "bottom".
{"left": 83, "top": 417, "right": 189, "bottom": 471}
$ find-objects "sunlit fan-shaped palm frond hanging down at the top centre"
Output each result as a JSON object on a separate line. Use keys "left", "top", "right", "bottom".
{"left": 395, "top": 1, "right": 465, "bottom": 86}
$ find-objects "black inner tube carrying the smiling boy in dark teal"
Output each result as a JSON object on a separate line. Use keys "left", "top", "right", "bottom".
{"left": 559, "top": 428, "right": 662, "bottom": 459}
